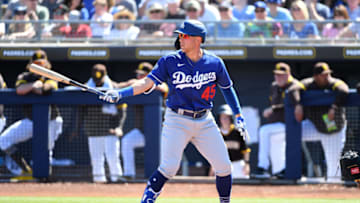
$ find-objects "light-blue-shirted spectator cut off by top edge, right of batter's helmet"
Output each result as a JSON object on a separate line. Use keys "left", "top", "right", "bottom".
{"left": 232, "top": 0, "right": 255, "bottom": 20}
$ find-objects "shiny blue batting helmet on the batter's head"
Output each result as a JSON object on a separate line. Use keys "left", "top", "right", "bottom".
{"left": 174, "top": 20, "right": 207, "bottom": 43}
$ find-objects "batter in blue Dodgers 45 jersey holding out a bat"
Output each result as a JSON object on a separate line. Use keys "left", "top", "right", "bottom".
{"left": 100, "top": 20, "right": 246, "bottom": 203}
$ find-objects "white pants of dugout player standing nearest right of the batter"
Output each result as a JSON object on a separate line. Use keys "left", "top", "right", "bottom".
{"left": 258, "top": 122, "right": 286, "bottom": 174}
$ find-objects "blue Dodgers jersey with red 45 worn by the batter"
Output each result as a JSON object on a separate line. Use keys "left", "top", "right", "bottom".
{"left": 147, "top": 50, "right": 233, "bottom": 111}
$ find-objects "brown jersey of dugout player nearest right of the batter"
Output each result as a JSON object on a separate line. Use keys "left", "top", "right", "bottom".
{"left": 268, "top": 76, "right": 303, "bottom": 123}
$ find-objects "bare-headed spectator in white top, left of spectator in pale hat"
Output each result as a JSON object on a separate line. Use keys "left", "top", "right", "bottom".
{"left": 90, "top": 0, "right": 113, "bottom": 38}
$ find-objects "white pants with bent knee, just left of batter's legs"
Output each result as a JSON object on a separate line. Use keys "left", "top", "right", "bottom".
{"left": 121, "top": 128, "right": 145, "bottom": 177}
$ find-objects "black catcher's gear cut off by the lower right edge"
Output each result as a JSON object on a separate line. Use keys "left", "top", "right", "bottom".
{"left": 340, "top": 150, "right": 360, "bottom": 183}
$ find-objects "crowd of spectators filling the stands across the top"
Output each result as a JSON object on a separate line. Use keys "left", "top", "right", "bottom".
{"left": 0, "top": 0, "right": 360, "bottom": 40}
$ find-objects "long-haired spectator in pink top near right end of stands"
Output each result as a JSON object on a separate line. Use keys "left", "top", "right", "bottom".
{"left": 322, "top": 4, "right": 350, "bottom": 38}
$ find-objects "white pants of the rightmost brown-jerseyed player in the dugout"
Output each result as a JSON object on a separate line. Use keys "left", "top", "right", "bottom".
{"left": 302, "top": 120, "right": 346, "bottom": 178}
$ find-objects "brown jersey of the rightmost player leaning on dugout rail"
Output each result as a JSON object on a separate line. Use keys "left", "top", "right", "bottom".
{"left": 301, "top": 77, "right": 348, "bottom": 134}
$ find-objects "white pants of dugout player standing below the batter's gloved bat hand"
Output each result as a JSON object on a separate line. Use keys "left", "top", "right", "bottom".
{"left": 88, "top": 135, "right": 122, "bottom": 182}
